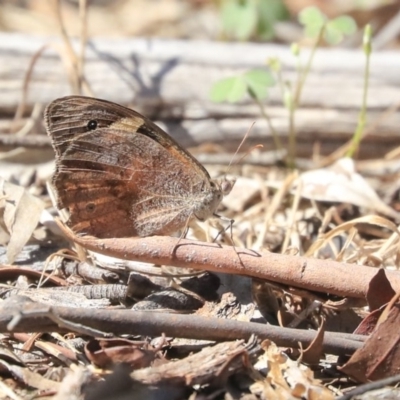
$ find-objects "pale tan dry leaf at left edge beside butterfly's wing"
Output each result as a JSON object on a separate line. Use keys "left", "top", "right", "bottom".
{"left": 0, "top": 177, "right": 44, "bottom": 264}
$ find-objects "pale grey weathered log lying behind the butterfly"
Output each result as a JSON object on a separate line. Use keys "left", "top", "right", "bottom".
{"left": 0, "top": 33, "right": 400, "bottom": 155}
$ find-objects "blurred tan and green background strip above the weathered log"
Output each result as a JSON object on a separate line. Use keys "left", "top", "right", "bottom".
{"left": 0, "top": 0, "right": 400, "bottom": 46}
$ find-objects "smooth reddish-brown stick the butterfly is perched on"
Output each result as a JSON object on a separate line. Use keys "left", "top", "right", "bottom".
{"left": 61, "top": 231, "right": 400, "bottom": 298}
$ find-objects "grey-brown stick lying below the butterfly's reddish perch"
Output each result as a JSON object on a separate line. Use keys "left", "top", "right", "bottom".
{"left": 0, "top": 297, "right": 365, "bottom": 355}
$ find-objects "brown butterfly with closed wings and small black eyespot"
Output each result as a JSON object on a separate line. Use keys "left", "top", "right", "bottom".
{"left": 45, "top": 96, "right": 232, "bottom": 238}
